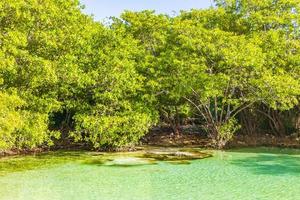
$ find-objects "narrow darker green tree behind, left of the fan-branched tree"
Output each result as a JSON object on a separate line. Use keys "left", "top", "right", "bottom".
{"left": 113, "top": 11, "right": 189, "bottom": 136}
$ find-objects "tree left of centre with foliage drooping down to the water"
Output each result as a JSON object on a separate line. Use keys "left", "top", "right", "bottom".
{"left": 70, "top": 22, "right": 155, "bottom": 149}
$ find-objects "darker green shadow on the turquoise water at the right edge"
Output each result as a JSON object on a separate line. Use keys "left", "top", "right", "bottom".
{"left": 230, "top": 153, "right": 300, "bottom": 176}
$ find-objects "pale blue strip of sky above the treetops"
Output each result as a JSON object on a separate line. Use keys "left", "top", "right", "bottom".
{"left": 80, "top": 0, "right": 212, "bottom": 21}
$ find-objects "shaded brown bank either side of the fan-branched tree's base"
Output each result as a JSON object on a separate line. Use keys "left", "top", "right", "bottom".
{"left": 142, "top": 126, "right": 300, "bottom": 149}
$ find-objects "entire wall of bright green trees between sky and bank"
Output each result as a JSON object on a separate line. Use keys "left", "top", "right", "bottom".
{"left": 0, "top": 0, "right": 300, "bottom": 149}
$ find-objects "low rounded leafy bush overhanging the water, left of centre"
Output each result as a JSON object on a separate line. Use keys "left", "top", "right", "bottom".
{"left": 74, "top": 112, "right": 151, "bottom": 149}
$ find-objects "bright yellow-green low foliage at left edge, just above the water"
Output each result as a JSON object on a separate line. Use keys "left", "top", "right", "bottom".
{"left": 0, "top": 93, "right": 59, "bottom": 149}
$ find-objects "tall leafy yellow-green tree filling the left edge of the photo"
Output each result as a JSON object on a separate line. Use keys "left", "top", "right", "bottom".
{"left": 0, "top": 0, "right": 91, "bottom": 148}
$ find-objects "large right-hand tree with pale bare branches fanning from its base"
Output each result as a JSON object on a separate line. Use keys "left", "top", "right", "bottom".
{"left": 171, "top": 1, "right": 299, "bottom": 147}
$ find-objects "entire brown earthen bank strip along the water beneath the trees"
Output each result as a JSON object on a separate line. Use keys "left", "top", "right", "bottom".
{"left": 0, "top": 129, "right": 300, "bottom": 157}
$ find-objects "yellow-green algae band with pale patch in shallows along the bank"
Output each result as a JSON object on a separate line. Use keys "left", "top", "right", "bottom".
{"left": 0, "top": 148, "right": 211, "bottom": 176}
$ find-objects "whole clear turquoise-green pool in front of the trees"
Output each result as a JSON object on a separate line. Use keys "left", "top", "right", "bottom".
{"left": 0, "top": 148, "right": 300, "bottom": 200}
